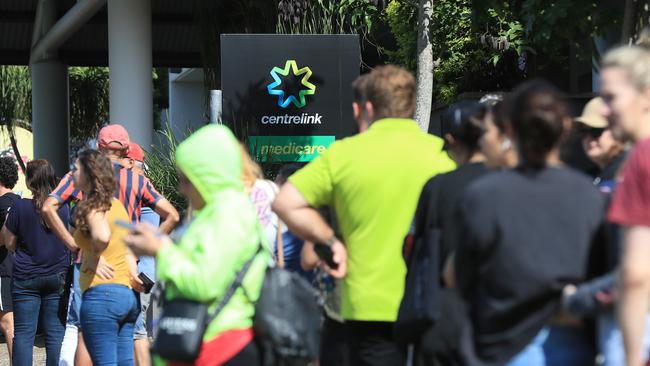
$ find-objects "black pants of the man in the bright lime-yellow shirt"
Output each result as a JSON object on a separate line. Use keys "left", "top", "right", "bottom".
{"left": 344, "top": 321, "right": 406, "bottom": 366}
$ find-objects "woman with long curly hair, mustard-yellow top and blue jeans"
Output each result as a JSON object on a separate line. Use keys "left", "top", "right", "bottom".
{"left": 73, "top": 150, "right": 142, "bottom": 365}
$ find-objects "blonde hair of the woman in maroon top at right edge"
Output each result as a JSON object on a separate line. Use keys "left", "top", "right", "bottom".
{"left": 602, "top": 45, "right": 650, "bottom": 90}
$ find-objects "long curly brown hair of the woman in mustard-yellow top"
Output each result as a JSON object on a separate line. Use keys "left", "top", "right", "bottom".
{"left": 74, "top": 150, "right": 116, "bottom": 235}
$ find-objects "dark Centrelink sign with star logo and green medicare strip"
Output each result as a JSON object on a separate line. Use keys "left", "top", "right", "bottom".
{"left": 221, "top": 34, "right": 360, "bottom": 162}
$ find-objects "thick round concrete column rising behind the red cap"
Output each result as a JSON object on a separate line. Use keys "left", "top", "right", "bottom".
{"left": 108, "top": 0, "right": 153, "bottom": 150}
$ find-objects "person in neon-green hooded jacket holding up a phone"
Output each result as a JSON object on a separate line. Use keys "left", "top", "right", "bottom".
{"left": 125, "top": 125, "right": 271, "bottom": 366}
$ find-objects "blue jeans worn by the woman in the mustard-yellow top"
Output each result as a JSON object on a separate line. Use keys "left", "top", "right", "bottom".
{"left": 81, "top": 284, "right": 140, "bottom": 366}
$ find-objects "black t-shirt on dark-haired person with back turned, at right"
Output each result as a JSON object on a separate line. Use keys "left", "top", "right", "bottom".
{"left": 456, "top": 167, "right": 606, "bottom": 365}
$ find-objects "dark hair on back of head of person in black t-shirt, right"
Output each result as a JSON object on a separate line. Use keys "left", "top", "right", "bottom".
{"left": 510, "top": 80, "right": 570, "bottom": 169}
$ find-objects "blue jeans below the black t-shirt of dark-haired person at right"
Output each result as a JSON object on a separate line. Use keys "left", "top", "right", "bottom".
{"left": 507, "top": 325, "right": 596, "bottom": 366}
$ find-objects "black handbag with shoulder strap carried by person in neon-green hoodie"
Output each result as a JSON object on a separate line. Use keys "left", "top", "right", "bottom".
{"left": 152, "top": 246, "right": 262, "bottom": 362}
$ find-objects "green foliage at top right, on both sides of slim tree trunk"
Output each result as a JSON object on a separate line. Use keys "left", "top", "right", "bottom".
{"left": 384, "top": 0, "right": 620, "bottom": 103}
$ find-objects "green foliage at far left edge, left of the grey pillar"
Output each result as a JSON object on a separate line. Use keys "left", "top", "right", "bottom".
{"left": 0, "top": 66, "right": 32, "bottom": 128}
